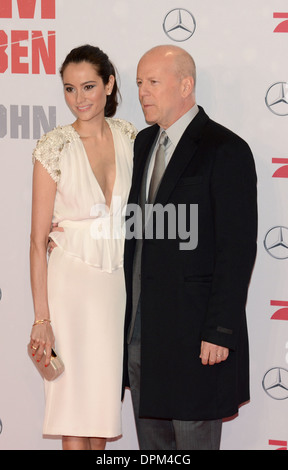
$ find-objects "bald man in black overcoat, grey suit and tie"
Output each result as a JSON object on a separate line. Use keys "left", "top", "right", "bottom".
{"left": 123, "top": 46, "right": 257, "bottom": 450}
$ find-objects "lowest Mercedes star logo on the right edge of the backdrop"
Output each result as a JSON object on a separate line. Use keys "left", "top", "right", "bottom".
{"left": 262, "top": 367, "right": 288, "bottom": 400}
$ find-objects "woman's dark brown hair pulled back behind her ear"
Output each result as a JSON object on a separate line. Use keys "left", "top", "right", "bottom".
{"left": 60, "top": 44, "right": 120, "bottom": 117}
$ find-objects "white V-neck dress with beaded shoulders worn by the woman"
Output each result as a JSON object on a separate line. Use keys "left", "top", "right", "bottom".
{"left": 33, "top": 118, "right": 136, "bottom": 438}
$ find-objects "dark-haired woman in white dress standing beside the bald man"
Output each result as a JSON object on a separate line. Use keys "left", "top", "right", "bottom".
{"left": 30, "top": 45, "right": 136, "bottom": 450}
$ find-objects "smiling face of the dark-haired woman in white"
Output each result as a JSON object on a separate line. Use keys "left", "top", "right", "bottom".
{"left": 63, "top": 62, "right": 114, "bottom": 121}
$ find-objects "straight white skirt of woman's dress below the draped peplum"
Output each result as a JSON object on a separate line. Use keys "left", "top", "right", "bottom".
{"left": 43, "top": 247, "right": 126, "bottom": 438}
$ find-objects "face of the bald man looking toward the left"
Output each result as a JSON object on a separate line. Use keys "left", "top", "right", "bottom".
{"left": 137, "top": 52, "right": 184, "bottom": 129}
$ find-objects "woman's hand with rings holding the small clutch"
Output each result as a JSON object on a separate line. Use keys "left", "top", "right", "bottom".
{"left": 30, "top": 320, "right": 55, "bottom": 367}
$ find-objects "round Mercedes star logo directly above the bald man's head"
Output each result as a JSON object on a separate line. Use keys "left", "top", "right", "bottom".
{"left": 163, "top": 8, "right": 196, "bottom": 42}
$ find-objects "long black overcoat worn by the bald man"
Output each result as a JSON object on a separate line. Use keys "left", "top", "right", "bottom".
{"left": 123, "top": 108, "right": 257, "bottom": 420}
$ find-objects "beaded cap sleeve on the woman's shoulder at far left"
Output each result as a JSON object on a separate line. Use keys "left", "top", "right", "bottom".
{"left": 32, "top": 125, "right": 79, "bottom": 183}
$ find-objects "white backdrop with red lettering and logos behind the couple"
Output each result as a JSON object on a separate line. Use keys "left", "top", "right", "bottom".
{"left": 0, "top": 0, "right": 288, "bottom": 450}
